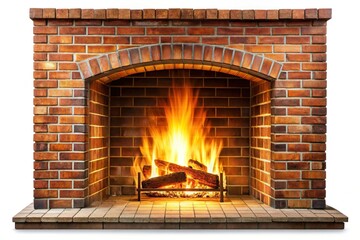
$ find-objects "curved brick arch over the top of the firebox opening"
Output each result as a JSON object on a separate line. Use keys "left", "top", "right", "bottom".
{"left": 78, "top": 44, "right": 282, "bottom": 83}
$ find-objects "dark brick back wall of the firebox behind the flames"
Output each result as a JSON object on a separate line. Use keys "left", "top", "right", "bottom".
{"left": 110, "top": 70, "right": 250, "bottom": 195}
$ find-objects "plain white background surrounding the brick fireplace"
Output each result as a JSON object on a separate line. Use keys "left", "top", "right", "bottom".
{"left": 0, "top": 0, "right": 360, "bottom": 240}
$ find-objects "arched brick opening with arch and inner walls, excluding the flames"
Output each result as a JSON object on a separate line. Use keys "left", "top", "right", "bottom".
{"left": 79, "top": 44, "right": 281, "bottom": 204}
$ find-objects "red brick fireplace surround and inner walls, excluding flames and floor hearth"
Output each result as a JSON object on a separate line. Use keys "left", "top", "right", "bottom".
{"left": 30, "top": 9, "right": 331, "bottom": 212}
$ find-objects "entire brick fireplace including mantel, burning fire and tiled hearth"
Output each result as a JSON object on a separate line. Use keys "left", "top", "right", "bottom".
{"left": 13, "top": 8, "right": 347, "bottom": 229}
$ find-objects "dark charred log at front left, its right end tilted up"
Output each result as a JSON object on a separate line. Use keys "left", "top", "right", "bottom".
{"left": 141, "top": 172, "right": 186, "bottom": 188}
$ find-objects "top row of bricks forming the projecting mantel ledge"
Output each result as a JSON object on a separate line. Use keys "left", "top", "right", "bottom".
{"left": 30, "top": 8, "right": 331, "bottom": 20}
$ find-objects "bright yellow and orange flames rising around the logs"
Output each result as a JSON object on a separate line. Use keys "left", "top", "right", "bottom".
{"left": 135, "top": 83, "right": 222, "bottom": 194}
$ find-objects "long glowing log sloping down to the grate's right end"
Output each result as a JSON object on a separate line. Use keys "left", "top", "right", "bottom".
{"left": 155, "top": 159, "right": 219, "bottom": 188}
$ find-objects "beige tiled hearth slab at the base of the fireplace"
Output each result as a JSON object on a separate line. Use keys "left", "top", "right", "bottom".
{"left": 13, "top": 196, "right": 348, "bottom": 229}
